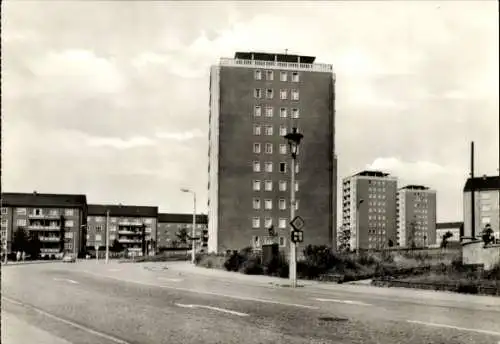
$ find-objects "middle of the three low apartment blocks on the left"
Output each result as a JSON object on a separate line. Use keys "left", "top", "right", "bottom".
{"left": 86, "top": 204, "right": 158, "bottom": 255}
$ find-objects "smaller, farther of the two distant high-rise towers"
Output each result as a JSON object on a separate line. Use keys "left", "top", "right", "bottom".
{"left": 397, "top": 185, "right": 436, "bottom": 247}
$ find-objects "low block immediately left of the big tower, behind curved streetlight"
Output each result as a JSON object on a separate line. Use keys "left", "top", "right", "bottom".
{"left": 157, "top": 213, "right": 208, "bottom": 250}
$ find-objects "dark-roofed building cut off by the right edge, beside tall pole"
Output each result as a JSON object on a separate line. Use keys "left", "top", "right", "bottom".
{"left": 464, "top": 176, "right": 500, "bottom": 239}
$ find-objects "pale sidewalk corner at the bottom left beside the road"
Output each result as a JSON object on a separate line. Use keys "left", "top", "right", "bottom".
{"left": 1, "top": 311, "right": 71, "bottom": 344}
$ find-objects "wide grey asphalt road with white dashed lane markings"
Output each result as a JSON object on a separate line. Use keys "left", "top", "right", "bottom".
{"left": 2, "top": 262, "right": 500, "bottom": 344}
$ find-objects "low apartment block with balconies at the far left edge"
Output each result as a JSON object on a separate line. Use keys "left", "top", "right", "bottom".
{"left": 1, "top": 191, "right": 87, "bottom": 256}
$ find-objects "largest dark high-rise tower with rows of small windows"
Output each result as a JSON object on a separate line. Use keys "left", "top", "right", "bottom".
{"left": 208, "top": 52, "right": 337, "bottom": 252}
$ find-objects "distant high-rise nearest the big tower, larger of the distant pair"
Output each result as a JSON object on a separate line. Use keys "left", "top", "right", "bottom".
{"left": 342, "top": 171, "right": 397, "bottom": 250}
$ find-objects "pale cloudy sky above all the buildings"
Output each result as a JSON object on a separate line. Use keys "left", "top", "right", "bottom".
{"left": 1, "top": 0, "right": 499, "bottom": 221}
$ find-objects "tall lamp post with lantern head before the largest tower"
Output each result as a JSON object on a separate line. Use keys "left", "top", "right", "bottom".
{"left": 285, "top": 128, "right": 304, "bottom": 288}
